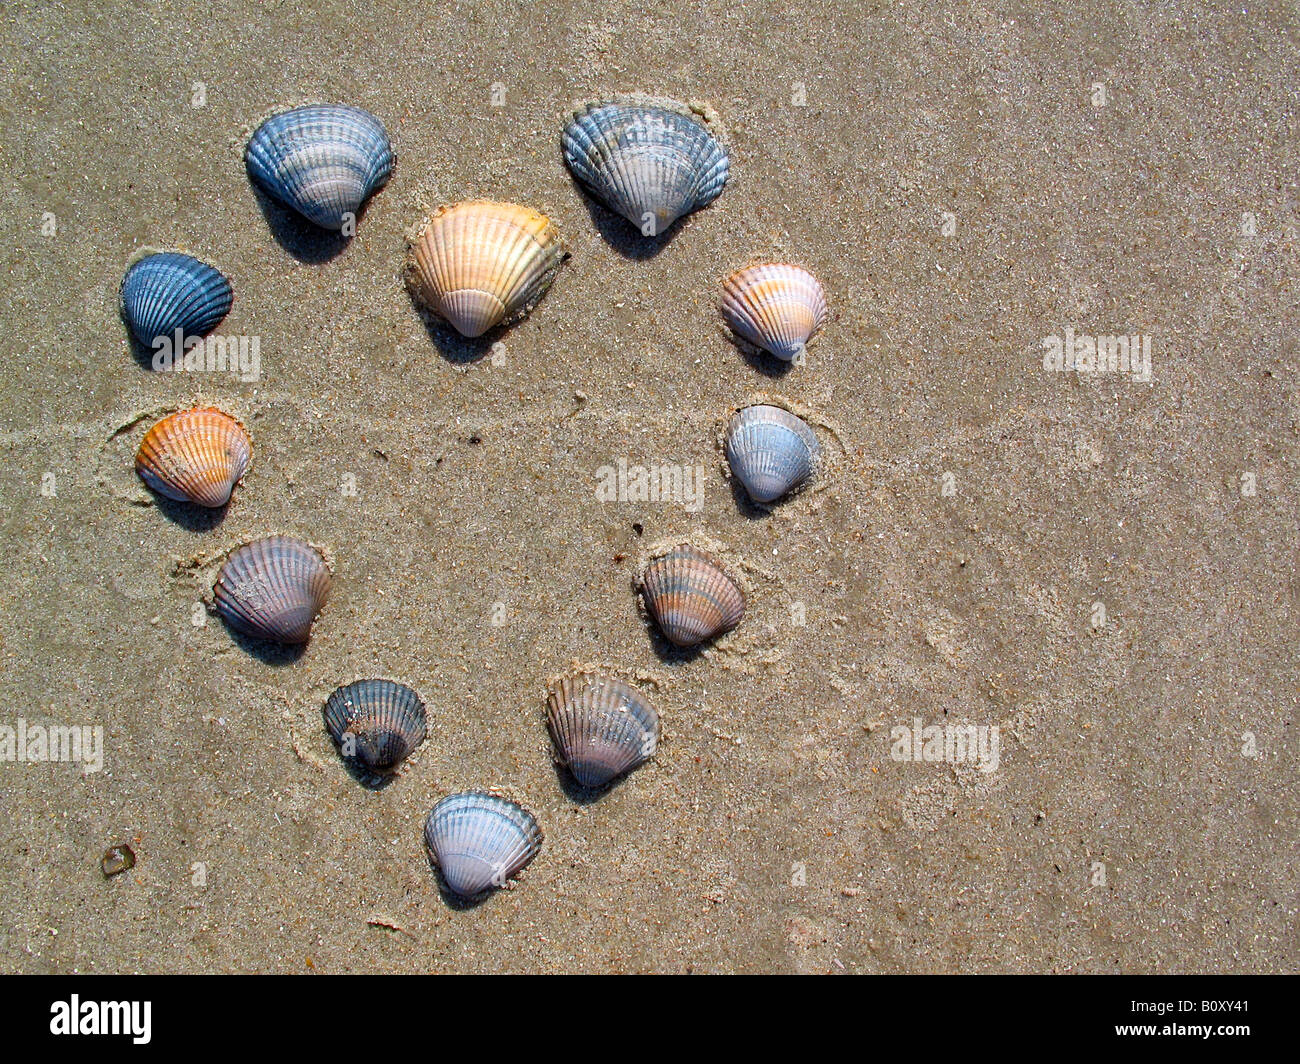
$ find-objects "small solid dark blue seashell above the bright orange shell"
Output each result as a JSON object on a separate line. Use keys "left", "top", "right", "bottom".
{"left": 122, "top": 251, "right": 234, "bottom": 347}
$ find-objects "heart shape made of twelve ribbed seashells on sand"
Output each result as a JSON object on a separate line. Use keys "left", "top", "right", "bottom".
{"left": 121, "top": 96, "right": 828, "bottom": 901}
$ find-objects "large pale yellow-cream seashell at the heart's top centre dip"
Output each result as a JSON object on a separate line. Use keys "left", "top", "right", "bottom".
{"left": 408, "top": 199, "right": 564, "bottom": 337}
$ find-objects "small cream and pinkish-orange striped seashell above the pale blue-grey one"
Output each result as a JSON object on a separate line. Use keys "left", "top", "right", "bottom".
{"left": 719, "top": 263, "right": 827, "bottom": 362}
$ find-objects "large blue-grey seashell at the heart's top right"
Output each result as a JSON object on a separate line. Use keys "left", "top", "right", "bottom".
{"left": 562, "top": 103, "right": 731, "bottom": 237}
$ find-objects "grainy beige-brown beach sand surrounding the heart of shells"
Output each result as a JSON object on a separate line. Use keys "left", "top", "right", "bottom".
{"left": 0, "top": 0, "right": 1300, "bottom": 973}
